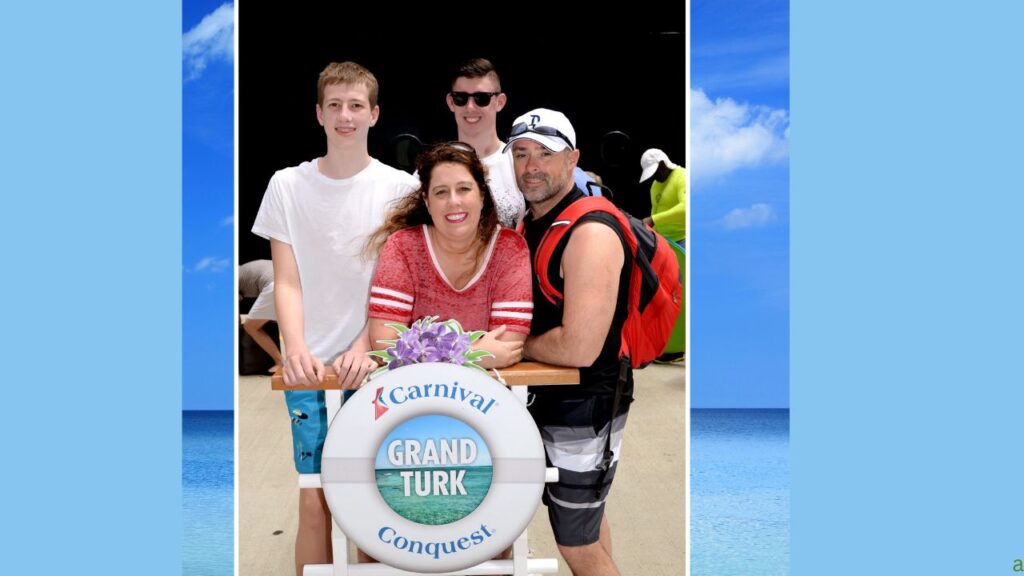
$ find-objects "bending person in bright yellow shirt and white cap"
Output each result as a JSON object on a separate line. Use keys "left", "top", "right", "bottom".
{"left": 640, "top": 148, "right": 686, "bottom": 362}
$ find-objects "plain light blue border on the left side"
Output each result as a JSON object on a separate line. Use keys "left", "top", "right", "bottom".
{"left": 0, "top": 2, "right": 181, "bottom": 576}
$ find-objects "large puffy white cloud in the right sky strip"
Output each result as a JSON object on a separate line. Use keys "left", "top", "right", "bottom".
{"left": 690, "top": 88, "right": 790, "bottom": 179}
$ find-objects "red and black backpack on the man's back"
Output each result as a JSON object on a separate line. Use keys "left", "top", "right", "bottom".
{"left": 534, "top": 196, "right": 683, "bottom": 368}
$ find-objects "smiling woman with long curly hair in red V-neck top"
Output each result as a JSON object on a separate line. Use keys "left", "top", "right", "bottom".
{"left": 368, "top": 142, "right": 534, "bottom": 368}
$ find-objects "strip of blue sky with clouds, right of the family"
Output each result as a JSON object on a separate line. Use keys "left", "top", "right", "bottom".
{"left": 688, "top": 0, "right": 790, "bottom": 408}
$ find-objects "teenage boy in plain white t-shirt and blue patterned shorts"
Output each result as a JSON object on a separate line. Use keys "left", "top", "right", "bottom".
{"left": 253, "top": 61, "right": 419, "bottom": 576}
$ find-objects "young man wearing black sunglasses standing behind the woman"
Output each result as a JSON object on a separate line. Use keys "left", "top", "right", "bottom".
{"left": 444, "top": 58, "right": 526, "bottom": 230}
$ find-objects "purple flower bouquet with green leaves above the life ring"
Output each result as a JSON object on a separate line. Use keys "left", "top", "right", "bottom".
{"left": 370, "top": 316, "right": 495, "bottom": 374}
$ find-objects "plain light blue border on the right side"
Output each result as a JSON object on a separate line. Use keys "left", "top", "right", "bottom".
{"left": 790, "top": 0, "right": 1024, "bottom": 576}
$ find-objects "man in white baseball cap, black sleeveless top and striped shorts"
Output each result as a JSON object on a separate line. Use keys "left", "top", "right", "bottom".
{"left": 506, "top": 109, "right": 633, "bottom": 576}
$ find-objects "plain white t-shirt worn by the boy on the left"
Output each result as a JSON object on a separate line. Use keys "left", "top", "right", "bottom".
{"left": 253, "top": 160, "right": 419, "bottom": 364}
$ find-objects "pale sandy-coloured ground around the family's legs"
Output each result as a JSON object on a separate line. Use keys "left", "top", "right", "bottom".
{"left": 237, "top": 365, "right": 689, "bottom": 576}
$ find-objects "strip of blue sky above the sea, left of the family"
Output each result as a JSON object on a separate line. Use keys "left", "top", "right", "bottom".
{"left": 181, "top": 0, "right": 237, "bottom": 410}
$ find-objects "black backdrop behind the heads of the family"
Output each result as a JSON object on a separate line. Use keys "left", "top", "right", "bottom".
{"left": 237, "top": 1, "right": 686, "bottom": 262}
